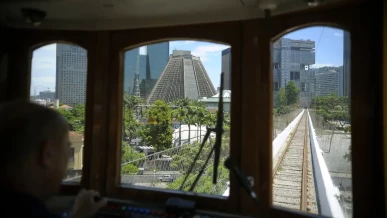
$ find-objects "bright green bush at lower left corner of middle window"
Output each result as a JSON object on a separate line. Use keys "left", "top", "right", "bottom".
{"left": 121, "top": 142, "right": 145, "bottom": 175}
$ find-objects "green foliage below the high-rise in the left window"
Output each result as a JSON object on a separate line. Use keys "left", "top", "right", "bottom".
{"left": 57, "top": 104, "right": 85, "bottom": 134}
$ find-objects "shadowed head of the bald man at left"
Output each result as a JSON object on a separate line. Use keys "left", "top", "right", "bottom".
{"left": 0, "top": 101, "right": 70, "bottom": 197}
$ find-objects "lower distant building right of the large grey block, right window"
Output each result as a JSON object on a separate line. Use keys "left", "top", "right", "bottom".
{"left": 316, "top": 70, "right": 339, "bottom": 96}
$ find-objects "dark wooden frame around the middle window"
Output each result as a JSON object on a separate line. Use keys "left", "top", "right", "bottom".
{"left": 106, "top": 22, "right": 242, "bottom": 212}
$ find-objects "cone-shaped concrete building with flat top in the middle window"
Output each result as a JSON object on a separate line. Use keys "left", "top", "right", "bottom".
{"left": 147, "top": 50, "right": 217, "bottom": 104}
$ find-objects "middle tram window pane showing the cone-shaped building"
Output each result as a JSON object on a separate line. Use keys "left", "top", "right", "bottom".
{"left": 121, "top": 41, "right": 231, "bottom": 196}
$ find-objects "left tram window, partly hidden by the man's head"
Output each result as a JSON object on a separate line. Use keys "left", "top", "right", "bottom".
{"left": 30, "top": 43, "right": 87, "bottom": 183}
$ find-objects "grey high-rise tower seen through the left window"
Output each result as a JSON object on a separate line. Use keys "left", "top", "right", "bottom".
{"left": 55, "top": 44, "right": 87, "bottom": 106}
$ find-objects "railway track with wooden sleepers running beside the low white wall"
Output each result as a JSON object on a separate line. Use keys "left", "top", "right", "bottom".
{"left": 273, "top": 111, "right": 318, "bottom": 214}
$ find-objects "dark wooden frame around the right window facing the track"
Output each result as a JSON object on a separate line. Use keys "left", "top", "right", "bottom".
{"left": 241, "top": 1, "right": 385, "bottom": 217}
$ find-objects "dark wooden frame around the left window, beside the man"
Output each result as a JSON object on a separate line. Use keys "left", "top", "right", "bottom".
{"left": 5, "top": 29, "right": 107, "bottom": 195}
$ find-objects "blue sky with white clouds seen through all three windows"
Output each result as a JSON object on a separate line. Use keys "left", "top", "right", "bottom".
{"left": 31, "top": 27, "right": 343, "bottom": 94}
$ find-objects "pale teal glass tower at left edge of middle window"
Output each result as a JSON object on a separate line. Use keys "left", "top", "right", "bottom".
{"left": 124, "top": 48, "right": 140, "bottom": 94}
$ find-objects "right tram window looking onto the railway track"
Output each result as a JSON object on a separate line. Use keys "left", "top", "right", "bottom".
{"left": 272, "top": 26, "right": 352, "bottom": 218}
